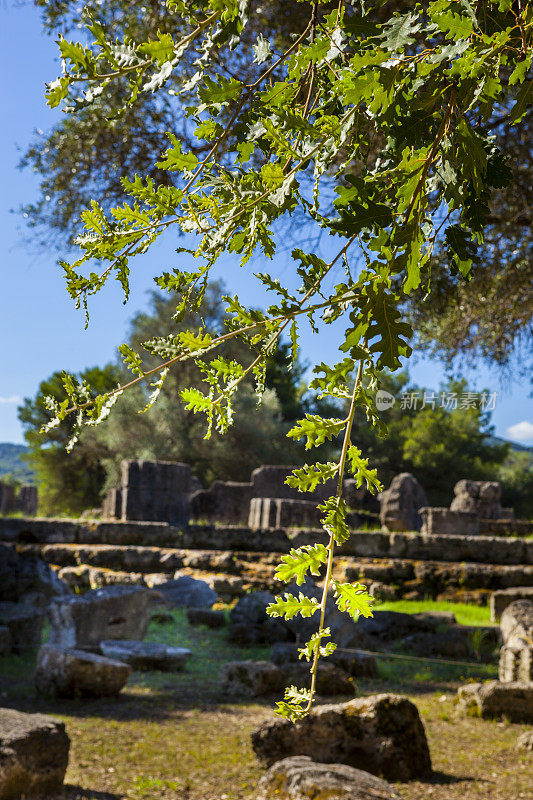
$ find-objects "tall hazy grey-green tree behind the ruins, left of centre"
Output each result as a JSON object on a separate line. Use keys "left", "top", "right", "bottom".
{"left": 91, "top": 282, "right": 309, "bottom": 487}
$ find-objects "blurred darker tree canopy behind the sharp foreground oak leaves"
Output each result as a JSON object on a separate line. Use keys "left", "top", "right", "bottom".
{"left": 21, "top": 0, "right": 533, "bottom": 375}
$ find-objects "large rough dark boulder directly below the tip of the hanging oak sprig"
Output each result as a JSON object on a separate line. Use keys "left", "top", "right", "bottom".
{"left": 252, "top": 694, "right": 431, "bottom": 781}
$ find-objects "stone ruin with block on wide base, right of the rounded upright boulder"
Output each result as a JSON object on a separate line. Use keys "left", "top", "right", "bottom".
{"left": 420, "top": 480, "right": 516, "bottom": 536}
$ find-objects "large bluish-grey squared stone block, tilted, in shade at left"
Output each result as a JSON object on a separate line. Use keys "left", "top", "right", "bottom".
{"left": 48, "top": 586, "right": 156, "bottom": 649}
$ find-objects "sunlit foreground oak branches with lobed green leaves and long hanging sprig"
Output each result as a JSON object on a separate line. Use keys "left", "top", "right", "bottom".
{"left": 42, "top": 0, "right": 533, "bottom": 719}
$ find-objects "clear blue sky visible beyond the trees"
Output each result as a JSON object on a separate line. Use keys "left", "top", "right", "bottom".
{"left": 0, "top": 2, "right": 533, "bottom": 444}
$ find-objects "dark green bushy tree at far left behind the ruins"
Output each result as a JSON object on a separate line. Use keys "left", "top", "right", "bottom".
{"left": 18, "top": 364, "right": 121, "bottom": 516}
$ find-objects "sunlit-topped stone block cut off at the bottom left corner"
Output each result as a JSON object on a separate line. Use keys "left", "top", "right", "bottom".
{"left": 0, "top": 708, "right": 70, "bottom": 800}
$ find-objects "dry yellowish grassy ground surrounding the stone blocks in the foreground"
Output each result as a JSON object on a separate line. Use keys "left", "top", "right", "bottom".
{"left": 0, "top": 614, "right": 533, "bottom": 800}
